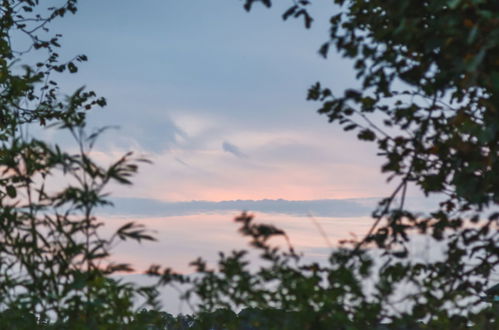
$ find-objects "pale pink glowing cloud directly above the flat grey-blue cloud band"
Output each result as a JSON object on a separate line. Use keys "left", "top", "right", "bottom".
{"left": 100, "top": 122, "right": 390, "bottom": 201}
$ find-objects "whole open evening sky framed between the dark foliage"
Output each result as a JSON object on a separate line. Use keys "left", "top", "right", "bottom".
{"left": 17, "top": 0, "right": 498, "bottom": 314}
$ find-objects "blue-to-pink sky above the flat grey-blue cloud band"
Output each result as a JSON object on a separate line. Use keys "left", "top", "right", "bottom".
{"left": 32, "top": 0, "right": 402, "bottom": 213}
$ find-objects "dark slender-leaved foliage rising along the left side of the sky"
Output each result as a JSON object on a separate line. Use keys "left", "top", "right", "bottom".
{"left": 0, "top": 0, "right": 160, "bottom": 329}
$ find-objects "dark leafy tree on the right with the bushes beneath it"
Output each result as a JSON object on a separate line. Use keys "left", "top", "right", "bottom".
{"left": 158, "top": 0, "right": 499, "bottom": 329}
